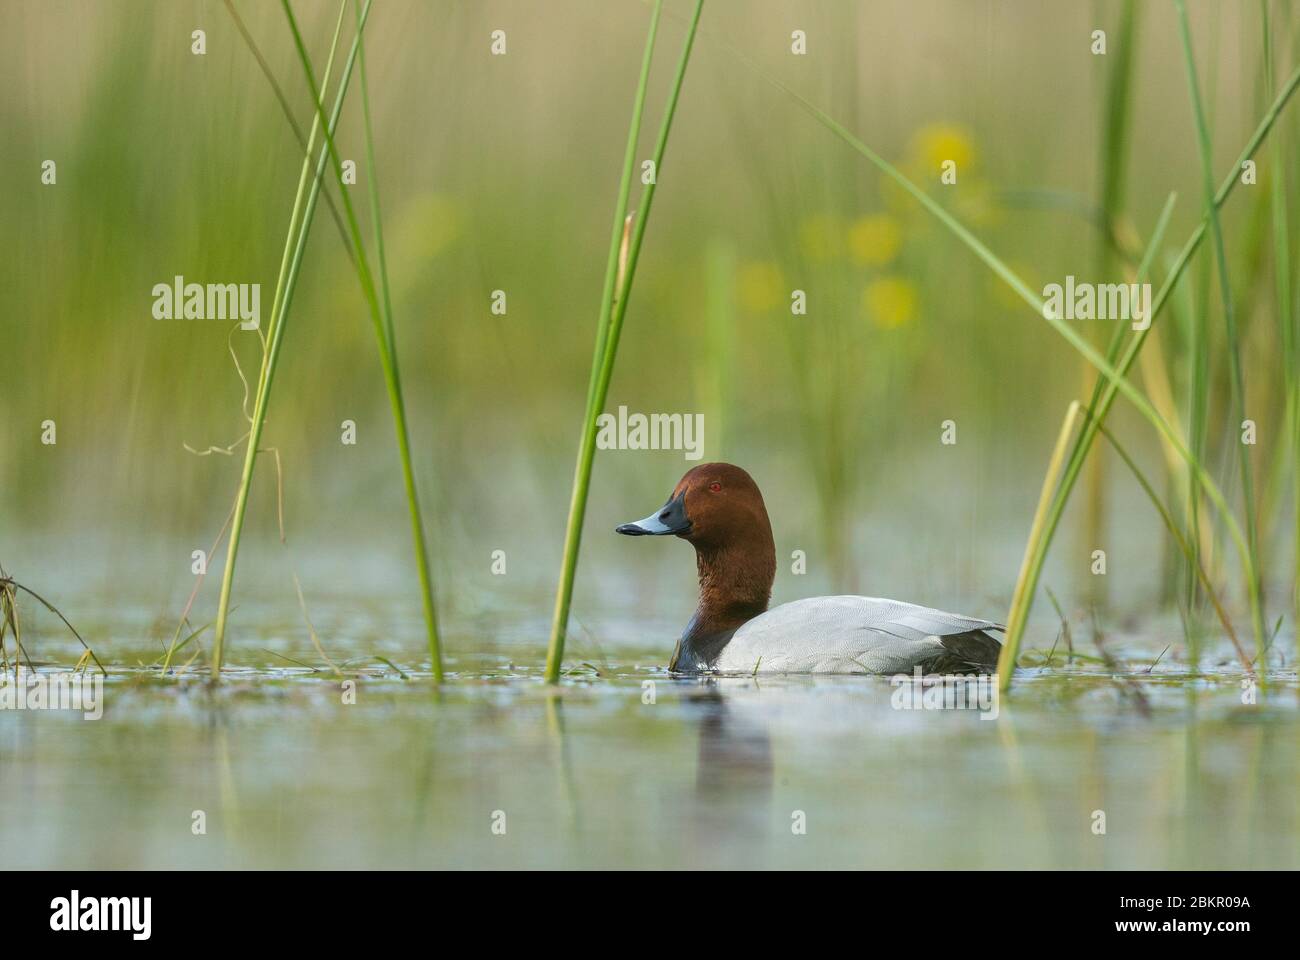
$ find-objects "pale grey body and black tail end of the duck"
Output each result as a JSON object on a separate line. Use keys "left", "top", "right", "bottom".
{"left": 712, "top": 597, "right": 1002, "bottom": 674}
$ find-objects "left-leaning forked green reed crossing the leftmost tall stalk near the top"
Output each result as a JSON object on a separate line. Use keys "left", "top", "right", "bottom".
{"left": 281, "top": 0, "right": 443, "bottom": 683}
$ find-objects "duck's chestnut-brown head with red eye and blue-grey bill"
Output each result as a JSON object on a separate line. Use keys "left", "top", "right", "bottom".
{"left": 615, "top": 463, "right": 772, "bottom": 550}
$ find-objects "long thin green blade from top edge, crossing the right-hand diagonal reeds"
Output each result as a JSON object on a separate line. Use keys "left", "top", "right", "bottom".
{"left": 1174, "top": 0, "right": 1266, "bottom": 654}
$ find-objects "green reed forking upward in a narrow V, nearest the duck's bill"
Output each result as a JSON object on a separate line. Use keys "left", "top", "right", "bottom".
{"left": 546, "top": 0, "right": 705, "bottom": 683}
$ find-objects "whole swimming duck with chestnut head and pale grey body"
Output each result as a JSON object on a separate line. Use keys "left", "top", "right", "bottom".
{"left": 615, "top": 463, "right": 1005, "bottom": 674}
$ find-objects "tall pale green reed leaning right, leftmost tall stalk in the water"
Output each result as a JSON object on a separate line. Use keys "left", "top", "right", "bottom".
{"left": 209, "top": 0, "right": 371, "bottom": 683}
